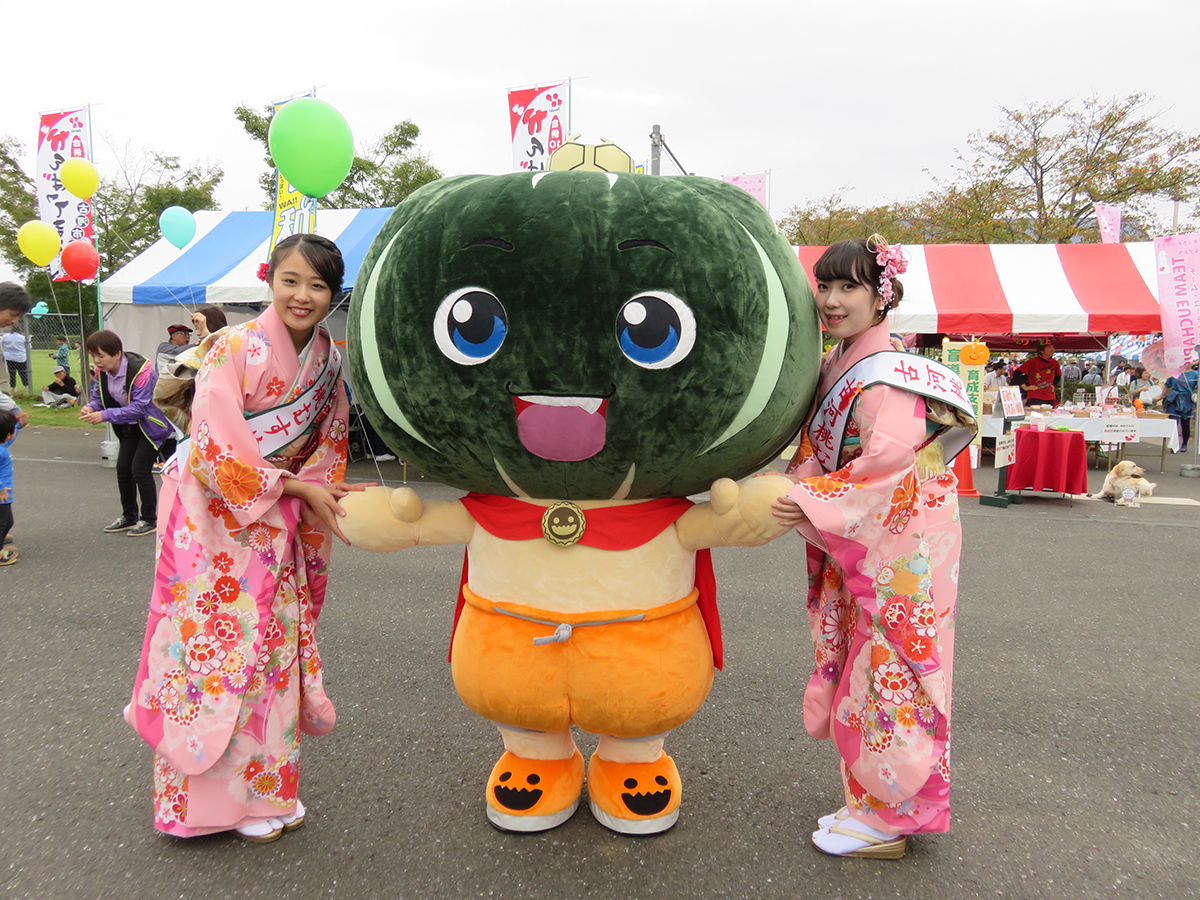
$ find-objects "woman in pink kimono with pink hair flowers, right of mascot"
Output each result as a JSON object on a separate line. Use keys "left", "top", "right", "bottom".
{"left": 775, "top": 236, "right": 974, "bottom": 858}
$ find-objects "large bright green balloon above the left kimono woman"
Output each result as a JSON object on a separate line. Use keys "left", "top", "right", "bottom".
{"left": 266, "top": 97, "right": 354, "bottom": 197}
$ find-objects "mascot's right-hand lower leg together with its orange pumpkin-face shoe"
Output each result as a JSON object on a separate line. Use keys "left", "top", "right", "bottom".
{"left": 588, "top": 734, "right": 682, "bottom": 834}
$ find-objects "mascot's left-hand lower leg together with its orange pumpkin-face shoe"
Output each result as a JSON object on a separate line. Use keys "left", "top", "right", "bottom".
{"left": 487, "top": 722, "right": 583, "bottom": 832}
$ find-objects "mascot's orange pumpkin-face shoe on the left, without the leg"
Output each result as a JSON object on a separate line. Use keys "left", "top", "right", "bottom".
{"left": 487, "top": 750, "right": 583, "bottom": 832}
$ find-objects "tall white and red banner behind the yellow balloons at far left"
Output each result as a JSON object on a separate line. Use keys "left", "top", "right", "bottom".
{"left": 36, "top": 109, "right": 96, "bottom": 281}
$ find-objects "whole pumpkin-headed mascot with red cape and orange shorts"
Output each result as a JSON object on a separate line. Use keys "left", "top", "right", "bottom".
{"left": 342, "top": 144, "right": 821, "bottom": 834}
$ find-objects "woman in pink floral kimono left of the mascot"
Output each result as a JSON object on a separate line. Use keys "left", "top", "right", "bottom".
{"left": 125, "top": 234, "right": 360, "bottom": 841}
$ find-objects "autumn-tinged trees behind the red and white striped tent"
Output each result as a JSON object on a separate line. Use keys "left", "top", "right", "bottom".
{"left": 779, "top": 94, "right": 1200, "bottom": 246}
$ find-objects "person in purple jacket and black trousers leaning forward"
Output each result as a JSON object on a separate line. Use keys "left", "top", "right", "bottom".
{"left": 79, "top": 331, "right": 173, "bottom": 536}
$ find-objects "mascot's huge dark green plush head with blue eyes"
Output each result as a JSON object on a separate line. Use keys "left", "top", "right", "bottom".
{"left": 349, "top": 172, "right": 821, "bottom": 499}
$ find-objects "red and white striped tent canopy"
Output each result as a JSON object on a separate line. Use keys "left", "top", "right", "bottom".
{"left": 796, "top": 241, "right": 1163, "bottom": 335}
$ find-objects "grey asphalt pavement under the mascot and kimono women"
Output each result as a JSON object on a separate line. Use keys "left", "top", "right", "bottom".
{"left": 0, "top": 428, "right": 1200, "bottom": 900}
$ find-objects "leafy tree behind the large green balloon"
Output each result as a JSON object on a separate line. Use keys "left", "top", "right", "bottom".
{"left": 234, "top": 106, "right": 442, "bottom": 209}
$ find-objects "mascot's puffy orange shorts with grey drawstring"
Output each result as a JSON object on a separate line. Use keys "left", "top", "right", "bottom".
{"left": 451, "top": 586, "right": 713, "bottom": 738}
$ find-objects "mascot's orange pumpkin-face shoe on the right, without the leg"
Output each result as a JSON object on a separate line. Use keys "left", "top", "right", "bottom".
{"left": 588, "top": 754, "right": 683, "bottom": 834}
